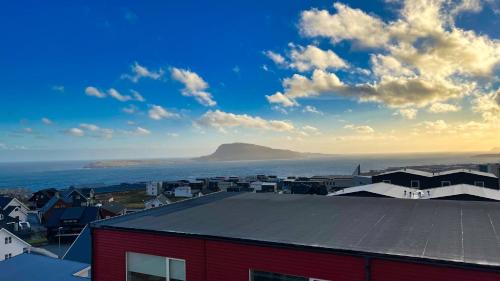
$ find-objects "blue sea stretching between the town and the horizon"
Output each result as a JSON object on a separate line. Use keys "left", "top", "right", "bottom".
{"left": 0, "top": 153, "right": 500, "bottom": 191}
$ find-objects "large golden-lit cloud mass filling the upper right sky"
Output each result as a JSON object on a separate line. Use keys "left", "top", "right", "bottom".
{"left": 266, "top": 0, "right": 500, "bottom": 120}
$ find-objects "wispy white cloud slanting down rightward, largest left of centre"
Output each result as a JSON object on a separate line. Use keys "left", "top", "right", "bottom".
{"left": 170, "top": 67, "right": 217, "bottom": 106}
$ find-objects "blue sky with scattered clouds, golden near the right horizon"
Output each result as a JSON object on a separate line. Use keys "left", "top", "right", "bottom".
{"left": 0, "top": 0, "right": 500, "bottom": 161}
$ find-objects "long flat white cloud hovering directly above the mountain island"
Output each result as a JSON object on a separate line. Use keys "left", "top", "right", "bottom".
{"left": 196, "top": 110, "right": 294, "bottom": 132}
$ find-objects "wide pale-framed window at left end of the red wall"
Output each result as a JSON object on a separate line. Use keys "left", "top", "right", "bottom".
{"left": 127, "top": 252, "right": 186, "bottom": 281}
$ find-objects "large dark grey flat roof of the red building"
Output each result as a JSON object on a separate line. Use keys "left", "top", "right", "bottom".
{"left": 93, "top": 193, "right": 500, "bottom": 267}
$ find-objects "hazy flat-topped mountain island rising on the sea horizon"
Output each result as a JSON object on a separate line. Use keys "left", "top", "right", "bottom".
{"left": 194, "top": 143, "right": 332, "bottom": 161}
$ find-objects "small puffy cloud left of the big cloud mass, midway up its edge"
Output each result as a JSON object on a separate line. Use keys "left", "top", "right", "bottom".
{"left": 289, "top": 44, "right": 348, "bottom": 72}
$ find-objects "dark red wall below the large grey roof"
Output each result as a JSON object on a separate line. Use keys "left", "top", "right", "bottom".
{"left": 92, "top": 229, "right": 500, "bottom": 281}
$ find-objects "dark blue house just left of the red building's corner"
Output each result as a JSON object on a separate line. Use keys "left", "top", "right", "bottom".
{"left": 46, "top": 207, "right": 101, "bottom": 241}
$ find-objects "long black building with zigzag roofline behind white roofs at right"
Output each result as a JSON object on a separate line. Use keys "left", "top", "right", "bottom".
{"left": 372, "top": 169, "right": 499, "bottom": 189}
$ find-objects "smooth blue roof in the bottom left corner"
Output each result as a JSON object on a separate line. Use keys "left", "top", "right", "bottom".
{"left": 0, "top": 254, "right": 90, "bottom": 281}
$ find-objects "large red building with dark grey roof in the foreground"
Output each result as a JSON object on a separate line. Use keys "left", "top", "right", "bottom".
{"left": 92, "top": 193, "right": 500, "bottom": 281}
